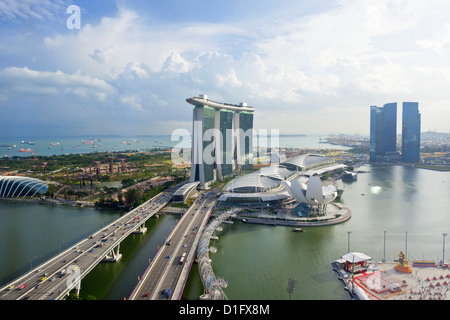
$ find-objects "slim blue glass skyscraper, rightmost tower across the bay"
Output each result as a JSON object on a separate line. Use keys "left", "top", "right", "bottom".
{"left": 402, "top": 102, "right": 421, "bottom": 162}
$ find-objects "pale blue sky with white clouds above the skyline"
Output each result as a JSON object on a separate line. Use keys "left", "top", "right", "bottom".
{"left": 0, "top": 0, "right": 450, "bottom": 138}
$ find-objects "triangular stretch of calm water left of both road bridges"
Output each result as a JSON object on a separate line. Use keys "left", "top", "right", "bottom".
{"left": 0, "top": 200, "right": 121, "bottom": 284}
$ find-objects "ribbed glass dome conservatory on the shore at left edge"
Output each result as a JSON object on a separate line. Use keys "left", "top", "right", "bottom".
{"left": 0, "top": 176, "right": 48, "bottom": 198}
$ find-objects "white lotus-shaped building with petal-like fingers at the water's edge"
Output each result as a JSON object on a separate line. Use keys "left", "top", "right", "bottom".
{"left": 284, "top": 174, "right": 338, "bottom": 216}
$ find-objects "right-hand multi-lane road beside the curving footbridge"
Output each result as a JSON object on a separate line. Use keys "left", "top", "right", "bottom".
{"left": 129, "top": 191, "right": 217, "bottom": 300}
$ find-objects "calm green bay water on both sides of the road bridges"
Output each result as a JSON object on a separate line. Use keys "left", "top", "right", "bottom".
{"left": 0, "top": 166, "right": 450, "bottom": 300}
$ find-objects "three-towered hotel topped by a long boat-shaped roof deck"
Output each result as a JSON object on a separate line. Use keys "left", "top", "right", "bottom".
{"left": 186, "top": 94, "right": 255, "bottom": 187}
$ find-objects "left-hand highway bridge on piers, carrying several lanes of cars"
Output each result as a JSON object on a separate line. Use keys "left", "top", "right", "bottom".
{"left": 0, "top": 185, "right": 180, "bottom": 300}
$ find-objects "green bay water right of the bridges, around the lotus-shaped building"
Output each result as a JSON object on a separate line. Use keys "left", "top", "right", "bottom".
{"left": 185, "top": 166, "right": 450, "bottom": 300}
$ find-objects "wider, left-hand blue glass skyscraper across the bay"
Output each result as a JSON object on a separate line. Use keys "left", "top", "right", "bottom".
{"left": 370, "top": 102, "right": 397, "bottom": 161}
